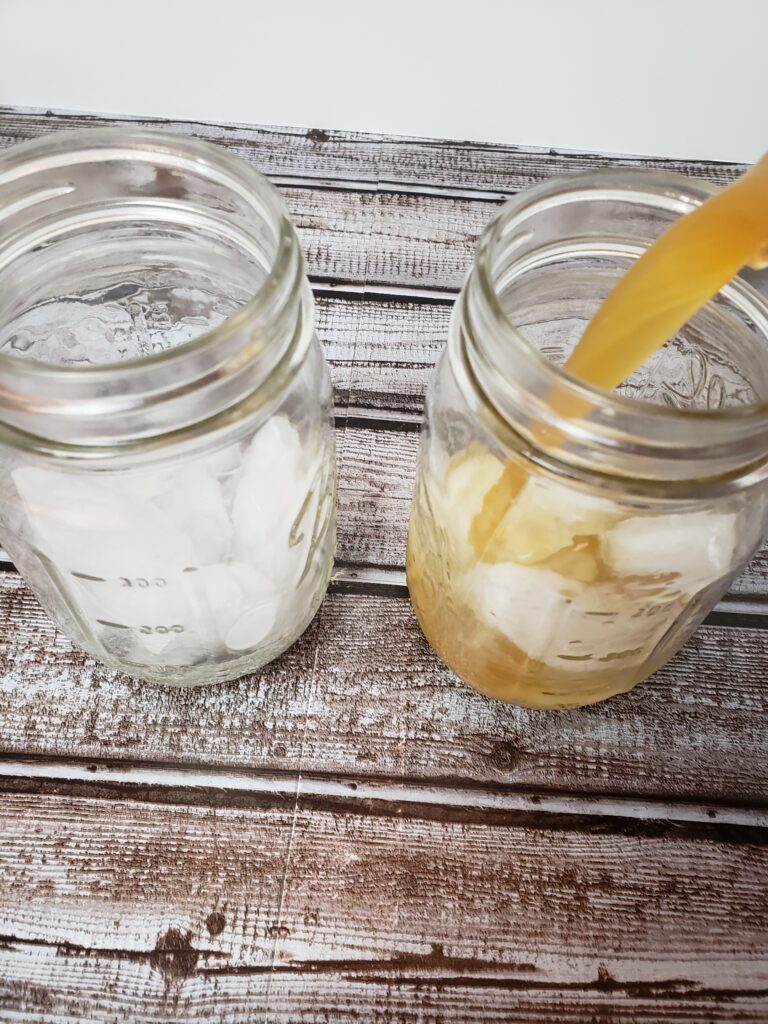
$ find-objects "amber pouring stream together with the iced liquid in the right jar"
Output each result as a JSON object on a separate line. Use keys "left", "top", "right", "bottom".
{"left": 408, "top": 159, "right": 768, "bottom": 708}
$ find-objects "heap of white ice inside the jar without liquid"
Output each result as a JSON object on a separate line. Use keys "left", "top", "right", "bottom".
{"left": 12, "top": 415, "right": 323, "bottom": 664}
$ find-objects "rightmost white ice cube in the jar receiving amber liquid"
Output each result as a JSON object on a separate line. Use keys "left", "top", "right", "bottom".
{"left": 602, "top": 512, "right": 736, "bottom": 589}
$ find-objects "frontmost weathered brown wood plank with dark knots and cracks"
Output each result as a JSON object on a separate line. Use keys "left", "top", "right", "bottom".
{"left": 0, "top": 792, "right": 768, "bottom": 1024}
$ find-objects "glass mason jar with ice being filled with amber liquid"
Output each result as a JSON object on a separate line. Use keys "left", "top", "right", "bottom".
{"left": 408, "top": 171, "right": 768, "bottom": 708}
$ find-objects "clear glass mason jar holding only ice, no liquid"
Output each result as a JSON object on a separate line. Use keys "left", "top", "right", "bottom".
{"left": 0, "top": 129, "right": 335, "bottom": 685}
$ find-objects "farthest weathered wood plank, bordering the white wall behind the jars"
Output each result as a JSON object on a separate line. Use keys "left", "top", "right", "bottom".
{"left": 0, "top": 108, "right": 742, "bottom": 196}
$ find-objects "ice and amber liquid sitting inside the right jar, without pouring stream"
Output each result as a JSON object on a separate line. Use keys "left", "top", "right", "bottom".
{"left": 408, "top": 445, "right": 736, "bottom": 708}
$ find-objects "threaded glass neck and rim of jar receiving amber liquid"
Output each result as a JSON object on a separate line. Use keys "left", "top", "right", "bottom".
{"left": 454, "top": 169, "right": 768, "bottom": 478}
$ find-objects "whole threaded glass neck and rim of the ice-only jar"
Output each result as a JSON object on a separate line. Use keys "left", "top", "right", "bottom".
{"left": 0, "top": 127, "right": 314, "bottom": 455}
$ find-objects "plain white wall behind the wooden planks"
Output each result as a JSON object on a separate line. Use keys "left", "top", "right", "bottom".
{"left": 0, "top": 0, "right": 768, "bottom": 161}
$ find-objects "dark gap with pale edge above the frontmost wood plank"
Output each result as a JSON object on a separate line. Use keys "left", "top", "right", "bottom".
{"left": 0, "top": 754, "right": 768, "bottom": 831}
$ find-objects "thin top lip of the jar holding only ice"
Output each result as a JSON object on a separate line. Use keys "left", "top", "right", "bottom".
{"left": 0, "top": 127, "right": 303, "bottom": 383}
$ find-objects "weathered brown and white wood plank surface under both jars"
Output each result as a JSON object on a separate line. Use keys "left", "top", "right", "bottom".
{"left": 0, "top": 111, "right": 768, "bottom": 1024}
